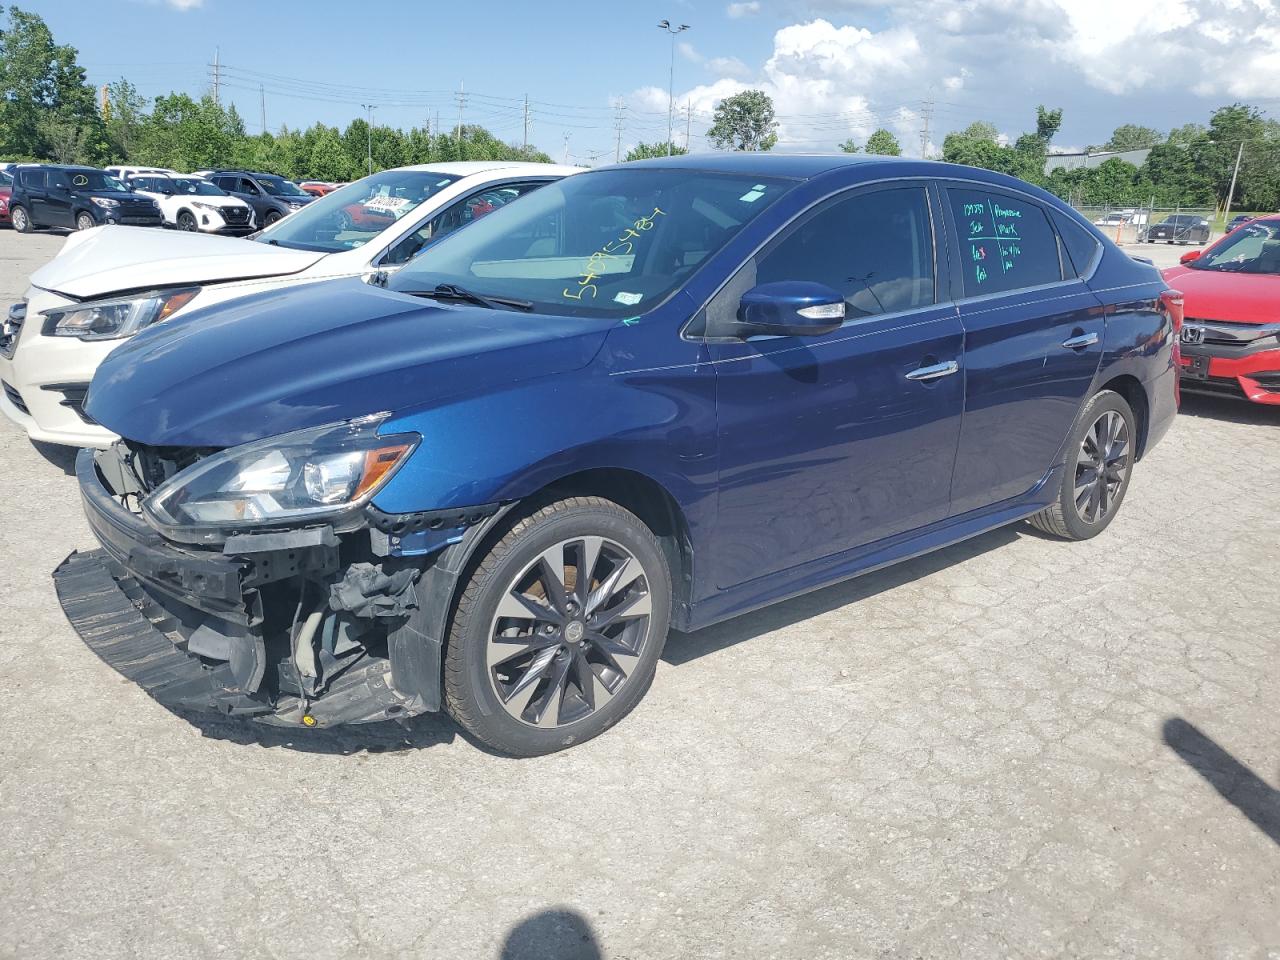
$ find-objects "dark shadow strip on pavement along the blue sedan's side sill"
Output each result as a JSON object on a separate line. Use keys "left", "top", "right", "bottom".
{"left": 662, "top": 524, "right": 1013, "bottom": 666}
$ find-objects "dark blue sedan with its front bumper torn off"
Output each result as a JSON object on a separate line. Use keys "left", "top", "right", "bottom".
{"left": 55, "top": 154, "right": 1180, "bottom": 755}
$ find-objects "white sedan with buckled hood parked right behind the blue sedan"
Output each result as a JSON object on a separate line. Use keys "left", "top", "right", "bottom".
{"left": 0, "top": 161, "right": 579, "bottom": 447}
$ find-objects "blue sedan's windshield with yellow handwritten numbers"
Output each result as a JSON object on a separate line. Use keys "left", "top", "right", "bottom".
{"left": 389, "top": 166, "right": 795, "bottom": 316}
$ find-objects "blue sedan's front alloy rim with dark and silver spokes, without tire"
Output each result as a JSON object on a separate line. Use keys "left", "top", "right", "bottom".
{"left": 485, "top": 536, "right": 652, "bottom": 728}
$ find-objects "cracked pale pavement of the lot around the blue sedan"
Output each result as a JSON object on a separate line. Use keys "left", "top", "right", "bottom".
{"left": 0, "top": 232, "right": 1280, "bottom": 960}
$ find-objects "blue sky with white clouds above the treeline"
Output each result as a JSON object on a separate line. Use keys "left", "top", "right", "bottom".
{"left": 27, "top": 0, "right": 1280, "bottom": 163}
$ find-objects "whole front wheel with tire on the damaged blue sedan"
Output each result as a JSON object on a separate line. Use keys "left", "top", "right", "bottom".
{"left": 444, "top": 497, "right": 671, "bottom": 756}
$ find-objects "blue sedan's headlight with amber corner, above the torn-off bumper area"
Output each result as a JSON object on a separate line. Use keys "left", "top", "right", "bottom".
{"left": 142, "top": 413, "right": 421, "bottom": 540}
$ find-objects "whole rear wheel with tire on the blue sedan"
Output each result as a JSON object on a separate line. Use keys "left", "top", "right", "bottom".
{"left": 1030, "top": 390, "right": 1138, "bottom": 540}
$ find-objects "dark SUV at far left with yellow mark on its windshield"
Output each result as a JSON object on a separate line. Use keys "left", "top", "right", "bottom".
{"left": 9, "top": 164, "right": 164, "bottom": 233}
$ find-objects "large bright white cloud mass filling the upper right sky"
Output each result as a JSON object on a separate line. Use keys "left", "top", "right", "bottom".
{"left": 632, "top": 0, "right": 1280, "bottom": 154}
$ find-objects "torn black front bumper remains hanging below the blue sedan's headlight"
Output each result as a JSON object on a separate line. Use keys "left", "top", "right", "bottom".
{"left": 54, "top": 451, "right": 439, "bottom": 727}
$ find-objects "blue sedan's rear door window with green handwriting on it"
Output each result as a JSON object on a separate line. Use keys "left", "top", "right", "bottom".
{"left": 947, "top": 188, "right": 1062, "bottom": 297}
